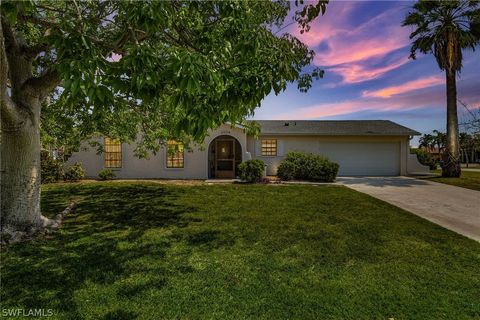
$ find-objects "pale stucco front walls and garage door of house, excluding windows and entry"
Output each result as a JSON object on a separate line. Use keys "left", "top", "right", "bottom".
{"left": 69, "top": 124, "right": 418, "bottom": 179}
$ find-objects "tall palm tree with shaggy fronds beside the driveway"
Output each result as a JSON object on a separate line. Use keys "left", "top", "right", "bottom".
{"left": 402, "top": 0, "right": 480, "bottom": 177}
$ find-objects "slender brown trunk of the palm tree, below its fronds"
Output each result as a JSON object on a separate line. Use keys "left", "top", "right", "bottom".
{"left": 442, "top": 69, "right": 461, "bottom": 177}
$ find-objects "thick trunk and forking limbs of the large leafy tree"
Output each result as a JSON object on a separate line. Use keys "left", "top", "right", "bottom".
{"left": 0, "top": 16, "right": 60, "bottom": 233}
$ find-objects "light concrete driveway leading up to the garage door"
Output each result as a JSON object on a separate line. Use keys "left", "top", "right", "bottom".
{"left": 337, "top": 177, "right": 480, "bottom": 242}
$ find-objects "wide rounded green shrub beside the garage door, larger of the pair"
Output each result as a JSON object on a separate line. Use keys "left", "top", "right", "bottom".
{"left": 277, "top": 152, "right": 339, "bottom": 182}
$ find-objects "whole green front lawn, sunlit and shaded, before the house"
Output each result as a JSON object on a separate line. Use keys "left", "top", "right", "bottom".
{"left": 1, "top": 182, "right": 480, "bottom": 320}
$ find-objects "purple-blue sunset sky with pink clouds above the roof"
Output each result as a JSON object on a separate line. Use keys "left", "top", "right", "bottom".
{"left": 253, "top": 0, "right": 480, "bottom": 144}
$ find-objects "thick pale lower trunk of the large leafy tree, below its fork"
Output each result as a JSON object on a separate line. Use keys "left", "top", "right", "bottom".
{"left": 0, "top": 98, "right": 43, "bottom": 232}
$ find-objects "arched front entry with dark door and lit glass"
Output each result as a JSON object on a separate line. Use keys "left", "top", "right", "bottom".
{"left": 208, "top": 135, "right": 242, "bottom": 179}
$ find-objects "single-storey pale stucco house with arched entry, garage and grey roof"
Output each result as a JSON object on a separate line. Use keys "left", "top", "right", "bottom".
{"left": 69, "top": 120, "right": 424, "bottom": 179}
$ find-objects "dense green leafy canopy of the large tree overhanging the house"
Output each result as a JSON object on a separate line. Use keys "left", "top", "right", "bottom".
{"left": 1, "top": 0, "right": 327, "bottom": 155}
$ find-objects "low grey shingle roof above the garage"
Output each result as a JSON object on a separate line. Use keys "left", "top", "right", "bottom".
{"left": 248, "top": 120, "right": 420, "bottom": 136}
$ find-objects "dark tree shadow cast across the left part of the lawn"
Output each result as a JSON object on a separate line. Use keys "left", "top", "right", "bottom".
{"left": 1, "top": 184, "right": 199, "bottom": 319}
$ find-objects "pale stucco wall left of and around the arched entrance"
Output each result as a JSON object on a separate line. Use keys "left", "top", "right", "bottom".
{"left": 68, "top": 125, "right": 249, "bottom": 179}
